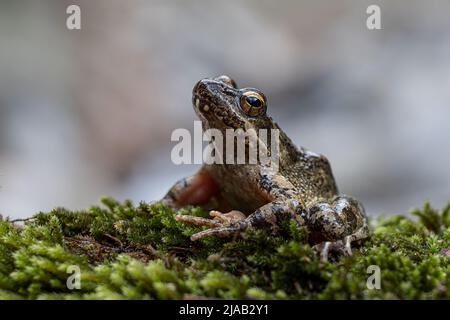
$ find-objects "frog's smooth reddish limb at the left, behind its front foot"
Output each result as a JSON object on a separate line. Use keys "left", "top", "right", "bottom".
{"left": 163, "top": 169, "right": 219, "bottom": 207}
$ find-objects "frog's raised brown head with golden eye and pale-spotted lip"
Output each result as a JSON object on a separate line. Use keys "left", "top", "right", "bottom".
{"left": 192, "top": 76, "right": 272, "bottom": 130}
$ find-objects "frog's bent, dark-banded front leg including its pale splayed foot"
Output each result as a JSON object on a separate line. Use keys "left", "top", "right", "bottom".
{"left": 176, "top": 175, "right": 304, "bottom": 241}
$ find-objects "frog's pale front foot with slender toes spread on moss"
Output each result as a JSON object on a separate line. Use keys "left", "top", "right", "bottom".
{"left": 175, "top": 210, "right": 247, "bottom": 241}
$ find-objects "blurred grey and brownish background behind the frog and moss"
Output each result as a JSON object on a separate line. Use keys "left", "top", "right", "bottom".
{"left": 0, "top": 0, "right": 450, "bottom": 218}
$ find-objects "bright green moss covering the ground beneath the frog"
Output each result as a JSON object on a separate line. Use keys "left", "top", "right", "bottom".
{"left": 0, "top": 198, "right": 450, "bottom": 299}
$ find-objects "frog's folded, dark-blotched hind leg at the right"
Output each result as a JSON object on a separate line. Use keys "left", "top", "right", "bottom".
{"left": 306, "top": 196, "right": 369, "bottom": 260}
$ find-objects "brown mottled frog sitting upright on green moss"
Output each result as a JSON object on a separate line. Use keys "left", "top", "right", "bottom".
{"left": 161, "top": 75, "right": 370, "bottom": 261}
